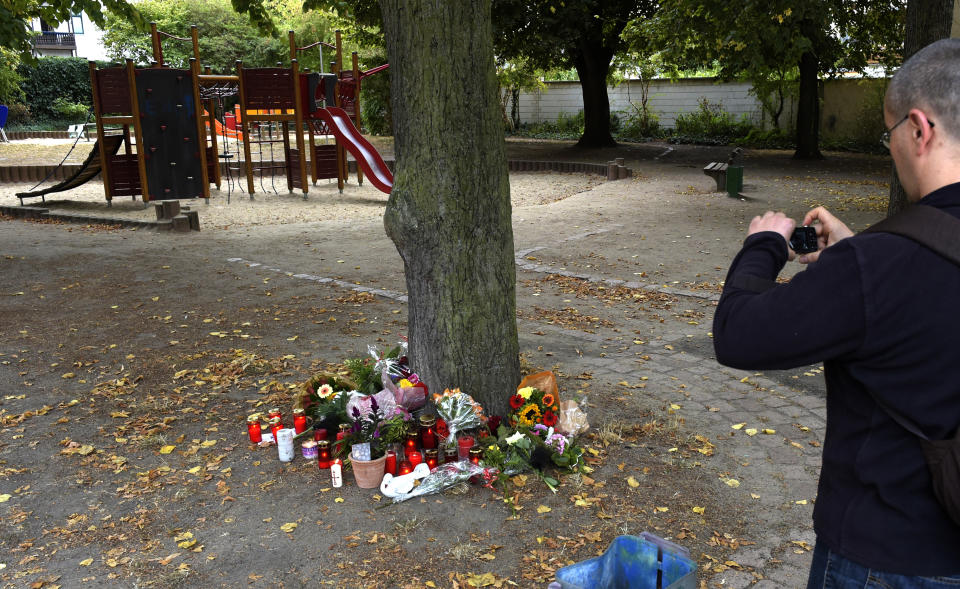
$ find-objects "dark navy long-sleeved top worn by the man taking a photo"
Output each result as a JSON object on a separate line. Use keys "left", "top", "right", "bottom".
{"left": 713, "top": 184, "right": 960, "bottom": 576}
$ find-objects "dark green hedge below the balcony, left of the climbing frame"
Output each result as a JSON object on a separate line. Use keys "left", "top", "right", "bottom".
{"left": 17, "top": 57, "right": 101, "bottom": 121}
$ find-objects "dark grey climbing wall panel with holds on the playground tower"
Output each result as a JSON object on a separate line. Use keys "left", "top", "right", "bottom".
{"left": 136, "top": 68, "right": 206, "bottom": 200}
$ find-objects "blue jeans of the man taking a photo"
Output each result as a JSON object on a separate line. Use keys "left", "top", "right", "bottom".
{"left": 807, "top": 542, "right": 960, "bottom": 589}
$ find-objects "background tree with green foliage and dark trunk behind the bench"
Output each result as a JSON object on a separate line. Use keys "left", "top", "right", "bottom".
{"left": 625, "top": 0, "right": 906, "bottom": 158}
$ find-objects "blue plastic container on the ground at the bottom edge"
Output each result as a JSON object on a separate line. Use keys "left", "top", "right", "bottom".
{"left": 551, "top": 532, "right": 697, "bottom": 589}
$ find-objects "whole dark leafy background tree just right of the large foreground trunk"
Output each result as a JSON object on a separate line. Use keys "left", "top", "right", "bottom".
{"left": 493, "top": 0, "right": 659, "bottom": 147}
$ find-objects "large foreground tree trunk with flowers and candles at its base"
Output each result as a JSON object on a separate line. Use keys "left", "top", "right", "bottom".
{"left": 380, "top": 0, "right": 520, "bottom": 415}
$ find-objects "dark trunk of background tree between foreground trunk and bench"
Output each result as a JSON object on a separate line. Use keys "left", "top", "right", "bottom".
{"left": 574, "top": 45, "right": 617, "bottom": 148}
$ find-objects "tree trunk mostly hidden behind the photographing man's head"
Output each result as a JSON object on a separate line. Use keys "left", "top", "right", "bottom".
{"left": 887, "top": 0, "right": 954, "bottom": 217}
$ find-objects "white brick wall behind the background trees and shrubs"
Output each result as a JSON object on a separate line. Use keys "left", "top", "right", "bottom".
{"left": 520, "top": 78, "right": 763, "bottom": 128}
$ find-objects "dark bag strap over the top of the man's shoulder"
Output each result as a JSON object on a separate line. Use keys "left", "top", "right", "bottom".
{"left": 863, "top": 205, "right": 960, "bottom": 266}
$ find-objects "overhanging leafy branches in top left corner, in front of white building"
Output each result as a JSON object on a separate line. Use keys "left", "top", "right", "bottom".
{"left": 0, "top": 0, "right": 143, "bottom": 59}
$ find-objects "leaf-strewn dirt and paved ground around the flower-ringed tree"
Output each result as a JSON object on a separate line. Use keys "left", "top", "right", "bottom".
{"left": 0, "top": 142, "right": 887, "bottom": 587}
